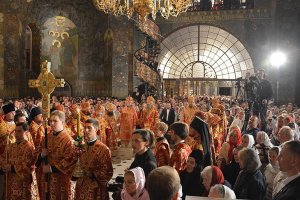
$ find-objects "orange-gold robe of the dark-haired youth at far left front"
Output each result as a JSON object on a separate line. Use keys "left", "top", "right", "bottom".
{"left": 1, "top": 140, "right": 36, "bottom": 200}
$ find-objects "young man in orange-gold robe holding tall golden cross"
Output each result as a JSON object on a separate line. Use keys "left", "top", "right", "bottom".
{"left": 29, "top": 61, "right": 76, "bottom": 200}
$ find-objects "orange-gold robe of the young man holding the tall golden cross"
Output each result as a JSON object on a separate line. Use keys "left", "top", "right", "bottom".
{"left": 40, "top": 130, "right": 76, "bottom": 200}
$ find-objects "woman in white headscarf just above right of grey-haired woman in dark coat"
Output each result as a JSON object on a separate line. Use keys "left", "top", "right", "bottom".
{"left": 255, "top": 131, "right": 273, "bottom": 172}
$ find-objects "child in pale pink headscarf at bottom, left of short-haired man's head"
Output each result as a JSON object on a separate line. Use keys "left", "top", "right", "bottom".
{"left": 121, "top": 167, "right": 150, "bottom": 200}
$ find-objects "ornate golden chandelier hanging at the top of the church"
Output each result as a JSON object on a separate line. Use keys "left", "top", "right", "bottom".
{"left": 93, "top": 0, "right": 192, "bottom": 20}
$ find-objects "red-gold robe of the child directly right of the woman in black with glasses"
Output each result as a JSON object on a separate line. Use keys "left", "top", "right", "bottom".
{"left": 154, "top": 137, "right": 171, "bottom": 167}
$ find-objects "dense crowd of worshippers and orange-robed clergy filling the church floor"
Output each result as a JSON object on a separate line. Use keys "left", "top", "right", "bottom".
{"left": 0, "top": 96, "right": 300, "bottom": 200}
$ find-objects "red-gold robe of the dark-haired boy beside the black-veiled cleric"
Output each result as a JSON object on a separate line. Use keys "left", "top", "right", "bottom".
{"left": 170, "top": 142, "right": 192, "bottom": 173}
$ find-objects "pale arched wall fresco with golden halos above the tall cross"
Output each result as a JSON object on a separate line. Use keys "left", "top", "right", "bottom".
{"left": 41, "top": 16, "right": 78, "bottom": 82}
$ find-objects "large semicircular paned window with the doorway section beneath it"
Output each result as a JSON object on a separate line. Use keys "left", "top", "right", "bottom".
{"left": 158, "top": 24, "right": 254, "bottom": 96}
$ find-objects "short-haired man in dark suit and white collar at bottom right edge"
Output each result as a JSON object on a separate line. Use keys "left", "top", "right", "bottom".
{"left": 273, "top": 140, "right": 300, "bottom": 200}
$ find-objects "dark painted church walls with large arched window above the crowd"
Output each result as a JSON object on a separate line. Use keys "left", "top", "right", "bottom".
{"left": 0, "top": 0, "right": 300, "bottom": 103}
